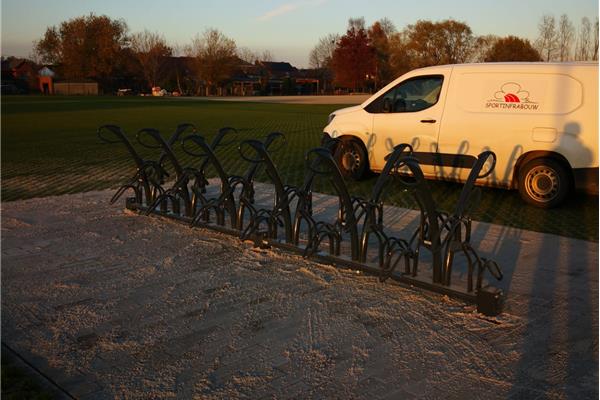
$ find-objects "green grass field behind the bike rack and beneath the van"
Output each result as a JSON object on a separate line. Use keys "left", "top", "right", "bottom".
{"left": 2, "top": 96, "right": 598, "bottom": 241}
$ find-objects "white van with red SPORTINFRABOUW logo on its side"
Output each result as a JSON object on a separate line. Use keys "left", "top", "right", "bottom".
{"left": 324, "top": 63, "right": 598, "bottom": 207}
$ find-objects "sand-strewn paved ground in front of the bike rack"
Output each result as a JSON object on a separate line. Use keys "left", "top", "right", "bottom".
{"left": 2, "top": 191, "right": 598, "bottom": 399}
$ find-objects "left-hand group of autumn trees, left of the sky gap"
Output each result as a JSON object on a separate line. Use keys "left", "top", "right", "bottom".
{"left": 34, "top": 14, "right": 271, "bottom": 94}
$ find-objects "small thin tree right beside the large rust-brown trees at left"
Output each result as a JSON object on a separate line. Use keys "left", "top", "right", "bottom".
{"left": 131, "top": 30, "right": 173, "bottom": 88}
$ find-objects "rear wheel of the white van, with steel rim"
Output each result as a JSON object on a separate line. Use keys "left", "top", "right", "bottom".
{"left": 519, "top": 158, "right": 571, "bottom": 208}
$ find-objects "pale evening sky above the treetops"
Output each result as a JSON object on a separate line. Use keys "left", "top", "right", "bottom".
{"left": 0, "top": 0, "right": 598, "bottom": 68}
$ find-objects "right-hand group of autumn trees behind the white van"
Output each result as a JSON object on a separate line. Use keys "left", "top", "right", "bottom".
{"left": 310, "top": 15, "right": 598, "bottom": 91}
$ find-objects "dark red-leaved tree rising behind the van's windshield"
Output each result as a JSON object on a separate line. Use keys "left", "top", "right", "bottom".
{"left": 331, "top": 18, "right": 376, "bottom": 91}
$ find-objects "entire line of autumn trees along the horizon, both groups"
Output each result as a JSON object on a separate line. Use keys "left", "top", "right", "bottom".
{"left": 35, "top": 14, "right": 598, "bottom": 94}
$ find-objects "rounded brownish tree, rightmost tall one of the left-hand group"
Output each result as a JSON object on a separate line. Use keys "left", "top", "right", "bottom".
{"left": 188, "top": 29, "right": 236, "bottom": 96}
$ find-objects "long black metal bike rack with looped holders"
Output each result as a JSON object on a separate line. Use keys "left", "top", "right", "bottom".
{"left": 98, "top": 124, "right": 504, "bottom": 315}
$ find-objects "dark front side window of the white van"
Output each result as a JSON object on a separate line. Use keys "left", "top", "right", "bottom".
{"left": 365, "top": 75, "right": 444, "bottom": 113}
